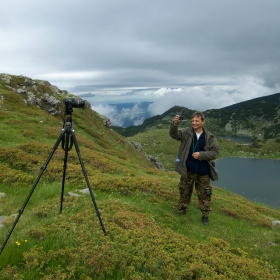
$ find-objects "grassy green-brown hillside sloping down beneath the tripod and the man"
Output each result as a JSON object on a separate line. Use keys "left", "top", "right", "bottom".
{"left": 0, "top": 75, "right": 280, "bottom": 279}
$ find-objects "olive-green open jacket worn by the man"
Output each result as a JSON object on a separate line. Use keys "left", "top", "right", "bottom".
{"left": 169, "top": 123, "right": 220, "bottom": 181}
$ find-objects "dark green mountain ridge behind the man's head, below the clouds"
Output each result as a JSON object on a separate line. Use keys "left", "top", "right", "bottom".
{"left": 112, "top": 93, "right": 280, "bottom": 139}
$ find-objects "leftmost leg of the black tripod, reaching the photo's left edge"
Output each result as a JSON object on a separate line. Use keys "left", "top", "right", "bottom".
{"left": 0, "top": 128, "right": 66, "bottom": 255}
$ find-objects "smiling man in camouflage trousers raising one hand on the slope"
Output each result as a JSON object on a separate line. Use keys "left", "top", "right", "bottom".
{"left": 169, "top": 112, "right": 219, "bottom": 225}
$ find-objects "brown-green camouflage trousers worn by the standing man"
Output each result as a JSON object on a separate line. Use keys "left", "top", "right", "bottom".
{"left": 178, "top": 172, "right": 212, "bottom": 217}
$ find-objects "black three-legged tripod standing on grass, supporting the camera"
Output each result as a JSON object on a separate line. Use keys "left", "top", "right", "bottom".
{"left": 0, "top": 104, "right": 106, "bottom": 255}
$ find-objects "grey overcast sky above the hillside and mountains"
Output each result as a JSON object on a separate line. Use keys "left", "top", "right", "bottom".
{"left": 0, "top": 0, "right": 280, "bottom": 115}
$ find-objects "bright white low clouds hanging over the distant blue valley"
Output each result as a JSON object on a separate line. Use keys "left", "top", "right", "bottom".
{"left": 92, "top": 80, "right": 276, "bottom": 127}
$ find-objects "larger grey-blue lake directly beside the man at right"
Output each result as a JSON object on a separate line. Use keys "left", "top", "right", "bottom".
{"left": 213, "top": 157, "right": 280, "bottom": 209}
